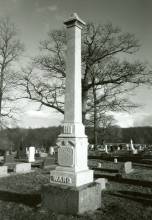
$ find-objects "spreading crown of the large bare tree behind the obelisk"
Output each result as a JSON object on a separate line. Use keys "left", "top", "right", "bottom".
{"left": 20, "top": 24, "right": 152, "bottom": 127}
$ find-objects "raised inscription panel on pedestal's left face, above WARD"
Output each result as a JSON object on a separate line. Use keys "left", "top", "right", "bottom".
{"left": 58, "top": 146, "right": 74, "bottom": 167}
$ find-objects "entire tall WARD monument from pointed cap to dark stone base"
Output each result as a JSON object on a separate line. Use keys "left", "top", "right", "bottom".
{"left": 42, "top": 13, "right": 101, "bottom": 214}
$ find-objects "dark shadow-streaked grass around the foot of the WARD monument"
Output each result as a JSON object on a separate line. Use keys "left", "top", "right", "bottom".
{"left": 0, "top": 164, "right": 152, "bottom": 220}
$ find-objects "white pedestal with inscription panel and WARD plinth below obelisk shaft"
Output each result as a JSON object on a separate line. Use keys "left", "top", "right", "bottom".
{"left": 50, "top": 134, "right": 93, "bottom": 187}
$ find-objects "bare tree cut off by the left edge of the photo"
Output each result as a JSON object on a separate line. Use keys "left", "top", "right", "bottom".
{"left": 0, "top": 18, "right": 23, "bottom": 126}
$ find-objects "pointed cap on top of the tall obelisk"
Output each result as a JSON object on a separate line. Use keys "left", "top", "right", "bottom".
{"left": 64, "top": 13, "right": 86, "bottom": 27}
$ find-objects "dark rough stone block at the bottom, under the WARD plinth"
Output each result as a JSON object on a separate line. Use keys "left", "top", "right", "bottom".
{"left": 42, "top": 182, "right": 101, "bottom": 214}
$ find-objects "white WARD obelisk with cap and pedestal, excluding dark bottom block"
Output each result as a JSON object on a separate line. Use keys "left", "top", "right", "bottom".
{"left": 50, "top": 13, "right": 93, "bottom": 186}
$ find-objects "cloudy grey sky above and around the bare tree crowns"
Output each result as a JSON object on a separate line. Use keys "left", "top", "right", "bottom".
{"left": 0, "top": 0, "right": 152, "bottom": 127}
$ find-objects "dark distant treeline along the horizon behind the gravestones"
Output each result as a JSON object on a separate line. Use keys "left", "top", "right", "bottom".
{"left": 0, "top": 127, "right": 152, "bottom": 149}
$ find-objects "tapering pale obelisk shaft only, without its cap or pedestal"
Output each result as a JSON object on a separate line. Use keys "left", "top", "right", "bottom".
{"left": 64, "top": 26, "right": 82, "bottom": 123}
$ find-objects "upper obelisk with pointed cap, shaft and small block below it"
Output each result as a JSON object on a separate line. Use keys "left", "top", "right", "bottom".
{"left": 64, "top": 14, "right": 85, "bottom": 137}
